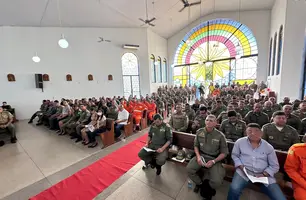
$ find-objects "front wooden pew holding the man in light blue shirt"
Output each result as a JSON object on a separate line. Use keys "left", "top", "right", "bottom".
{"left": 169, "top": 131, "right": 293, "bottom": 199}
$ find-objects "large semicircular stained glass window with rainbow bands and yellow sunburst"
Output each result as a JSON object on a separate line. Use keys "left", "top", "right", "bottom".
{"left": 173, "top": 19, "right": 258, "bottom": 85}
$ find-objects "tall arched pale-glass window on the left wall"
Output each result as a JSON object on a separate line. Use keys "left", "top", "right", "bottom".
{"left": 121, "top": 53, "right": 140, "bottom": 98}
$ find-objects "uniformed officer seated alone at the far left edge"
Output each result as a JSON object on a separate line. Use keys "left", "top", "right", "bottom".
{"left": 0, "top": 106, "right": 17, "bottom": 143}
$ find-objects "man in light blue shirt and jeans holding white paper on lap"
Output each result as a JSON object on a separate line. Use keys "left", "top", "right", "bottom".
{"left": 227, "top": 123, "right": 286, "bottom": 200}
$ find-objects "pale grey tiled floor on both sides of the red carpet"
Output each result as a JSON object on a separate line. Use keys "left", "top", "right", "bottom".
{"left": 0, "top": 121, "right": 267, "bottom": 200}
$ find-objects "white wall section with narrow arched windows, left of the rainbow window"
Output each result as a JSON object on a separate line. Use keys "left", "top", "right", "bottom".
{"left": 147, "top": 29, "right": 169, "bottom": 93}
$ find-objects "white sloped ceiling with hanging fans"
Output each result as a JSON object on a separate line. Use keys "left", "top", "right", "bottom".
{"left": 0, "top": 0, "right": 274, "bottom": 38}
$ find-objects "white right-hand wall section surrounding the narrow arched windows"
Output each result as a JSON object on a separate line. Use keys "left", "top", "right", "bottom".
{"left": 267, "top": 0, "right": 287, "bottom": 101}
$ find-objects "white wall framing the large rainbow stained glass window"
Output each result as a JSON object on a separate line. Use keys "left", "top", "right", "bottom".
{"left": 168, "top": 10, "right": 270, "bottom": 83}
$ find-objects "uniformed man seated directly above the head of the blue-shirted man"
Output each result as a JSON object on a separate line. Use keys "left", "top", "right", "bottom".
{"left": 244, "top": 103, "right": 269, "bottom": 127}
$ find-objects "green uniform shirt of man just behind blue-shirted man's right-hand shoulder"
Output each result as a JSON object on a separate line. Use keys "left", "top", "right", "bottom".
{"left": 262, "top": 123, "right": 300, "bottom": 151}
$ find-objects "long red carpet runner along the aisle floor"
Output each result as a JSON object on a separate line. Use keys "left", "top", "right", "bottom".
{"left": 30, "top": 135, "right": 147, "bottom": 200}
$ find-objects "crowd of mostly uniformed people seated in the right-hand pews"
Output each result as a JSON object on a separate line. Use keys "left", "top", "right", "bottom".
{"left": 139, "top": 84, "right": 306, "bottom": 200}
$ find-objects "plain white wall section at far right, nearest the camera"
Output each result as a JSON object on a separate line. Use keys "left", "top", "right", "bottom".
{"left": 279, "top": 0, "right": 306, "bottom": 100}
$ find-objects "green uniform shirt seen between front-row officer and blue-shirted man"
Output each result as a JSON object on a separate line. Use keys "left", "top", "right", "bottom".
{"left": 220, "top": 119, "right": 246, "bottom": 142}
